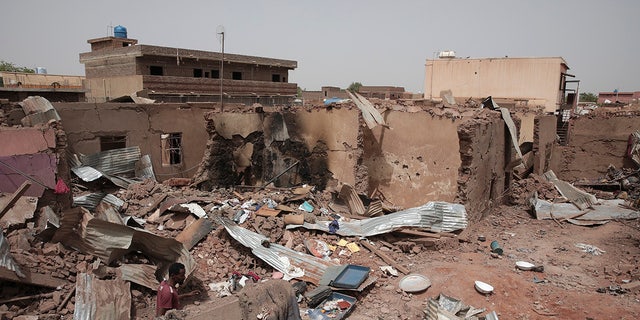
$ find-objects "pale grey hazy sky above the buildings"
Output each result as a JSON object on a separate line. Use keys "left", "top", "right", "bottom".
{"left": 0, "top": 0, "right": 640, "bottom": 94}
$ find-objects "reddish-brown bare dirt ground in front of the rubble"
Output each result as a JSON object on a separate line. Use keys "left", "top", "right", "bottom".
{"left": 138, "top": 206, "right": 640, "bottom": 319}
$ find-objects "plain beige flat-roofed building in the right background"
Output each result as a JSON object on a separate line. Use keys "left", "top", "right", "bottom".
{"left": 424, "top": 54, "right": 579, "bottom": 112}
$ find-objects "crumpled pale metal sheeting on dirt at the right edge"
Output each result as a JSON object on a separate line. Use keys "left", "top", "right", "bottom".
{"left": 531, "top": 197, "right": 640, "bottom": 225}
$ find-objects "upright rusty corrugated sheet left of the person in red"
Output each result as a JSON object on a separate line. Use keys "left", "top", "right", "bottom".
{"left": 73, "top": 273, "right": 131, "bottom": 320}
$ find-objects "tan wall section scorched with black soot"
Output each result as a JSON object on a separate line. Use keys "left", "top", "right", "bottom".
{"left": 196, "top": 108, "right": 359, "bottom": 188}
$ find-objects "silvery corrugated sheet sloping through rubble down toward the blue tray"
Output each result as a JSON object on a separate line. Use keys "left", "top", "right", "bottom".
{"left": 213, "top": 216, "right": 338, "bottom": 285}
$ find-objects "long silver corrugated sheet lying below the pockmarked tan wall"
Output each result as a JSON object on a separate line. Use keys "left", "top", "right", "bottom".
{"left": 287, "top": 201, "right": 467, "bottom": 237}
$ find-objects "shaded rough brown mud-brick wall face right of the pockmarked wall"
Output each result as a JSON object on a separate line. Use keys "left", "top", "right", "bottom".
{"left": 458, "top": 110, "right": 512, "bottom": 222}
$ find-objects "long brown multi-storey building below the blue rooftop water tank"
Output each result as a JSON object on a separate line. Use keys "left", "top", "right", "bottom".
{"left": 80, "top": 37, "right": 297, "bottom": 105}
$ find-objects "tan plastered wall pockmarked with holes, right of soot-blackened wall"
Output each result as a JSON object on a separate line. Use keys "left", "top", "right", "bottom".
{"left": 362, "top": 111, "right": 461, "bottom": 207}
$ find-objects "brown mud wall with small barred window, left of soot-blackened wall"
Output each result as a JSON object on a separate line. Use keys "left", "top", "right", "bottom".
{"left": 54, "top": 103, "right": 215, "bottom": 180}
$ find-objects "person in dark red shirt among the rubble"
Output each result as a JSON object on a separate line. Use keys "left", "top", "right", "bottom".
{"left": 156, "top": 262, "right": 200, "bottom": 316}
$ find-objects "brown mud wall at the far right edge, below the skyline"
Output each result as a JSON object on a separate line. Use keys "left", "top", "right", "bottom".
{"left": 551, "top": 111, "right": 640, "bottom": 181}
